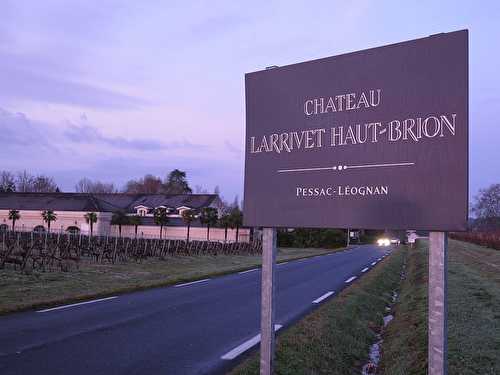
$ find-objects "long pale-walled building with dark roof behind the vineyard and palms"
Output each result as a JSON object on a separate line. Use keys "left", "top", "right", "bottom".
{"left": 0, "top": 193, "right": 249, "bottom": 241}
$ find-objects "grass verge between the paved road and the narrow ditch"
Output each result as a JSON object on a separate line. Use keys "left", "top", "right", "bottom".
{"left": 231, "top": 247, "right": 406, "bottom": 375}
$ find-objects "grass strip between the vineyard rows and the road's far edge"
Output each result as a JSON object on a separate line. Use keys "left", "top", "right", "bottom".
{"left": 0, "top": 248, "right": 343, "bottom": 314}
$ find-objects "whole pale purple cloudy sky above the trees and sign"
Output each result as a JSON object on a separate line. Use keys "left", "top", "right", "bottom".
{"left": 0, "top": 0, "right": 500, "bottom": 200}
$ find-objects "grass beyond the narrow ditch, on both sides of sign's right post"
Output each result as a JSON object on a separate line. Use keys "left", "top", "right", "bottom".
{"left": 380, "top": 240, "right": 500, "bottom": 375}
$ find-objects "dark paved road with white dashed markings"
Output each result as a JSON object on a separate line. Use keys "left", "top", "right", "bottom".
{"left": 0, "top": 245, "right": 386, "bottom": 375}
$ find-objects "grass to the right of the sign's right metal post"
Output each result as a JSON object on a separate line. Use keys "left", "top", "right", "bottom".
{"left": 448, "top": 241, "right": 500, "bottom": 375}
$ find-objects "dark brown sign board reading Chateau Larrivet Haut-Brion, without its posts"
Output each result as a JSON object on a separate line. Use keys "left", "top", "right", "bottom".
{"left": 244, "top": 30, "right": 468, "bottom": 231}
